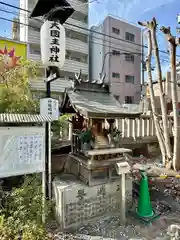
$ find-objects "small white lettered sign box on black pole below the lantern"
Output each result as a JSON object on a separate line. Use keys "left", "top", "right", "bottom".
{"left": 40, "top": 98, "right": 59, "bottom": 121}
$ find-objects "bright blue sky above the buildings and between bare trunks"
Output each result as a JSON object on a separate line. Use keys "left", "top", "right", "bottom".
{"left": 0, "top": 0, "right": 180, "bottom": 77}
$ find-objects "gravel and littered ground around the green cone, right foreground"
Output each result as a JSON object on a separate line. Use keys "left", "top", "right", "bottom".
{"left": 47, "top": 158, "right": 180, "bottom": 240}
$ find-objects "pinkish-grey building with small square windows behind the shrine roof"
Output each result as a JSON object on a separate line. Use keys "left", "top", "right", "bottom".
{"left": 89, "top": 16, "right": 141, "bottom": 104}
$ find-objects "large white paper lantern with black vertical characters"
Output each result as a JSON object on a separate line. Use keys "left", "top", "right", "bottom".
{"left": 40, "top": 21, "right": 65, "bottom": 68}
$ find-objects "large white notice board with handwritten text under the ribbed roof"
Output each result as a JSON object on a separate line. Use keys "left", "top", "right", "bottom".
{"left": 0, "top": 127, "right": 45, "bottom": 178}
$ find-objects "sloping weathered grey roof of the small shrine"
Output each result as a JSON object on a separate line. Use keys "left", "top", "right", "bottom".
{"left": 61, "top": 89, "right": 142, "bottom": 118}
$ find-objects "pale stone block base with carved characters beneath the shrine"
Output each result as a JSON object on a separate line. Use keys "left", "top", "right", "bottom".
{"left": 53, "top": 174, "right": 132, "bottom": 229}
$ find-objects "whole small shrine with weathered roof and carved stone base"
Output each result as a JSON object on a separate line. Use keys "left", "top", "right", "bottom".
{"left": 53, "top": 77, "right": 140, "bottom": 229}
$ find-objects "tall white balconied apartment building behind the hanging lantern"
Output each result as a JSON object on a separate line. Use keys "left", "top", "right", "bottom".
{"left": 19, "top": 0, "right": 89, "bottom": 98}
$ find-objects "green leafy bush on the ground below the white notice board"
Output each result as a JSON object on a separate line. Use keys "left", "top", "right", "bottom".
{"left": 0, "top": 175, "right": 52, "bottom": 240}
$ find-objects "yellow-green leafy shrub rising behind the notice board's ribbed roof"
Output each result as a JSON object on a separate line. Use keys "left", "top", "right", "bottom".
{"left": 0, "top": 60, "right": 39, "bottom": 113}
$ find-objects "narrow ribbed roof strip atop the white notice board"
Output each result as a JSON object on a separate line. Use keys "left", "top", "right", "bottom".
{"left": 0, "top": 113, "right": 52, "bottom": 123}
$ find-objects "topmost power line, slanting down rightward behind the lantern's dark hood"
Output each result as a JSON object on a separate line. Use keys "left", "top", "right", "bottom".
{"left": 0, "top": 1, "right": 180, "bottom": 57}
